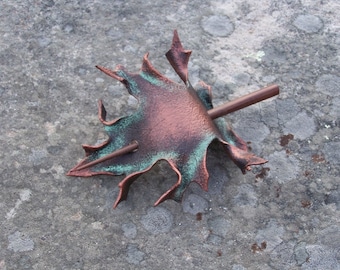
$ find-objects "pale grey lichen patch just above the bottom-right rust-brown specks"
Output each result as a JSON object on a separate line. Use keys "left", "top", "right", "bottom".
{"left": 255, "top": 219, "right": 284, "bottom": 251}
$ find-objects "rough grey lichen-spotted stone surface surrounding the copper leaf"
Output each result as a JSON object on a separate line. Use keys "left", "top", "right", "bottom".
{"left": 0, "top": 0, "right": 340, "bottom": 270}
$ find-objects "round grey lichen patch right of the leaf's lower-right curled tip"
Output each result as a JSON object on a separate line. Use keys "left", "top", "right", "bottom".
{"left": 268, "top": 151, "right": 300, "bottom": 184}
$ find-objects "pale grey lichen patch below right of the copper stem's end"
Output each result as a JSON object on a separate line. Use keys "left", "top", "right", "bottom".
{"left": 283, "top": 112, "right": 316, "bottom": 140}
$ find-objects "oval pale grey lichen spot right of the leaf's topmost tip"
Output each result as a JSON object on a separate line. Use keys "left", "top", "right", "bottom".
{"left": 202, "top": 15, "right": 234, "bottom": 37}
